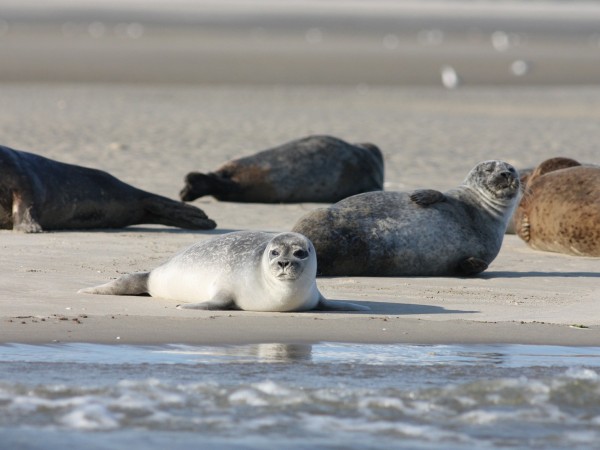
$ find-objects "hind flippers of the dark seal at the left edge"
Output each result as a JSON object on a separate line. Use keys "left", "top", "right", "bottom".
{"left": 144, "top": 196, "right": 217, "bottom": 230}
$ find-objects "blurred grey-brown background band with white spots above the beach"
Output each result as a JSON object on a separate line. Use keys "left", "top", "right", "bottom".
{"left": 0, "top": 0, "right": 600, "bottom": 89}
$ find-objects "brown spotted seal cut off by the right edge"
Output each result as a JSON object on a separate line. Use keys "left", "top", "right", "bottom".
{"left": 515, "top": 157, "right": 600, "bottom": 256}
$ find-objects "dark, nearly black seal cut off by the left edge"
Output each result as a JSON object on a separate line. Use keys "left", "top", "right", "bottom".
{"left": 0, "top": 146, "right": 216, "bottom": 233}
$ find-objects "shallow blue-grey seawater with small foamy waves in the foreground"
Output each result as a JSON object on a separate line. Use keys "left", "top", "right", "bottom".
{"left": 0, "top": 343, "right": 600, "bottom": 450}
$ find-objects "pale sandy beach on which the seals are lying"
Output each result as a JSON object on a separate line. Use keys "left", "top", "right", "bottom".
{"left": 0, "top": 2, "right": 600, "bottom": 345}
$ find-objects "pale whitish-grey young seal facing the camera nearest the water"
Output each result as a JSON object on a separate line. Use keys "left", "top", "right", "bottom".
{"left": 79, "top": 231, "right": 369, "bottom": 312}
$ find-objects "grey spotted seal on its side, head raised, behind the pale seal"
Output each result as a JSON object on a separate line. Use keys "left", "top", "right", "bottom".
{"left": 293, "top": 161, "right": 519, "bottom": 276}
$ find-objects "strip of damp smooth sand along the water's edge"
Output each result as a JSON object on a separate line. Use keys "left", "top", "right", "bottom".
{"left": 0, "top": 311, "right": 600, "bottom": 347}
